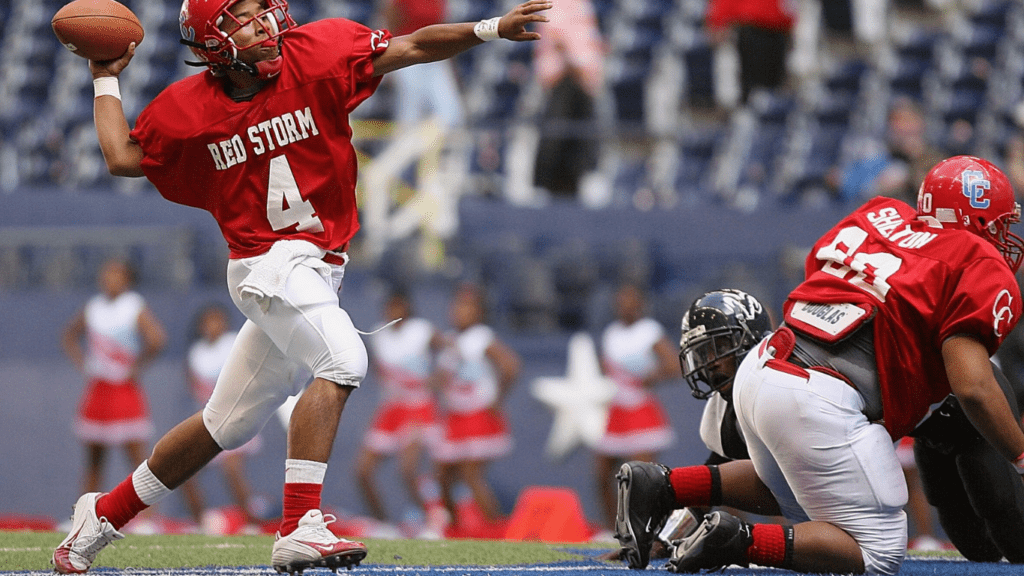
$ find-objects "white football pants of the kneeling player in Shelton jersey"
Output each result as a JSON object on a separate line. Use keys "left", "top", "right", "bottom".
{"left": 732, "top": 338, "right": 907, "bottom": 574}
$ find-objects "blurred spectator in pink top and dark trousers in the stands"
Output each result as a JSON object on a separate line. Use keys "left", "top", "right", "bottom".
{"left": 534, "top": 0, "right": 604, "bottom": 196}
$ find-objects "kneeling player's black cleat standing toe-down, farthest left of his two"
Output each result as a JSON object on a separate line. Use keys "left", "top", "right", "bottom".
{"left": 615, "top": 461, "right": 676, "bottom": 570}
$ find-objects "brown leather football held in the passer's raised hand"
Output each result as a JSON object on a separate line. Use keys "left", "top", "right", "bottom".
{"left": 50, "top": 0, "right": 144, "bottom": 60}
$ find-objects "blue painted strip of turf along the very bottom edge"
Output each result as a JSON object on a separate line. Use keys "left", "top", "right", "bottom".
{"left": 6, "top": 558, "right": 1022, "bottom": 576}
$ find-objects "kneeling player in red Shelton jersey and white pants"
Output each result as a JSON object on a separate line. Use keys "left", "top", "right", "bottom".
{"left": 616, "top": 156, "right": 1024, "bottom": 574}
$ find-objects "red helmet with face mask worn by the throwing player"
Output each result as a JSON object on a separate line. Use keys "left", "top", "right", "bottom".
{"left": 178, "top": 0, "right": 297, "bottom": 78}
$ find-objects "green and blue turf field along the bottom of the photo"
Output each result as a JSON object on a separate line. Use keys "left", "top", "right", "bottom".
{"left": 6, "top": 532, "right": 999, "bottom": 576}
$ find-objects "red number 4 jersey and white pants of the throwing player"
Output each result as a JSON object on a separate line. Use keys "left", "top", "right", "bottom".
{"left": 125, "top": 18, "right": 390, "bottom": 449}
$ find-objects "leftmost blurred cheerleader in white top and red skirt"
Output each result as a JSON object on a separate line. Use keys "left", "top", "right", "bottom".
{"left": 61, "top": 259, "right": 167, "bottom": 492}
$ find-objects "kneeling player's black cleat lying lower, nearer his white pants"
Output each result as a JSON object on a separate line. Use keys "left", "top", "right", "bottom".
{"left": 666, "top": 511, "right": 754, "bottom": 573}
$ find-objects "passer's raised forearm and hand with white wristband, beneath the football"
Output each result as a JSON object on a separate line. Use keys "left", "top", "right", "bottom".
{"left": 89, "top": 42, "right": 143, "bottom": 176}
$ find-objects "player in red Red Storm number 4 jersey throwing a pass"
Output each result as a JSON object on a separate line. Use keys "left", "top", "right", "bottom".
{"left": 53, "top": 0, "right": 551, "bottom": 573}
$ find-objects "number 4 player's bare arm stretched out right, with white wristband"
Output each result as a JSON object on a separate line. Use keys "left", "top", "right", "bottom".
{"left": 374, "top": 0, "right": 552, "bottom": 76}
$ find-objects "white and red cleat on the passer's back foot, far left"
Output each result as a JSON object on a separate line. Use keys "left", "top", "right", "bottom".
{"left": 51, "top": 492, "right": 124, "bottom": 574}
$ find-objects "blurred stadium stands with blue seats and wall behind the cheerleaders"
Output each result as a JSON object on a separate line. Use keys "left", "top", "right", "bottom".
{"left": 0, "top": 0, "right": 1024, "bottom": 545}
